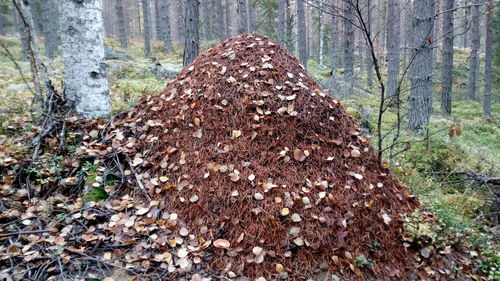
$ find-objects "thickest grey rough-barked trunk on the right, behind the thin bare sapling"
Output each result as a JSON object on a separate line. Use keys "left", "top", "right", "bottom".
{"left": 408, "top": 0, "right": 434, "bottom": 132}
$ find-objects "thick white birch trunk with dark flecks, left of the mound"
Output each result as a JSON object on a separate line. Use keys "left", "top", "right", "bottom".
{"left": 61, "top": 0, "right": 111, "bottom": 118}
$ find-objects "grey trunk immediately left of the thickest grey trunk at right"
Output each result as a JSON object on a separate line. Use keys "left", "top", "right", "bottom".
{"left": 387, "top": 0, "right": 401, "bottom": 98}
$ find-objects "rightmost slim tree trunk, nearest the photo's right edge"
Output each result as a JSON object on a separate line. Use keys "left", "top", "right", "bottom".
{"left": 483, "top": 0, "right": 495, "bottom": 118}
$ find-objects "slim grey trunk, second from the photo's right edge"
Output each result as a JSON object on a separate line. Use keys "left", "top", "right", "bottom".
{"left": 467, "top": 0, "right": 481, "bottom": 100}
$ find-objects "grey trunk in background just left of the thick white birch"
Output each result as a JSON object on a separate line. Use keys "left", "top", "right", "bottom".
{"left": 40, "top": 0, "right": 59, "bottom": 58}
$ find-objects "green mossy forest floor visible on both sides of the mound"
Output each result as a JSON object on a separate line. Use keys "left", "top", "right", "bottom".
{"left": 0, "top": 35, "right": 500, "bottom": 280}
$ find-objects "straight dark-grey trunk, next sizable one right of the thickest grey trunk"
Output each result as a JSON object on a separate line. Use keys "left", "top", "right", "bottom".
{"left": 441, "top": 0, "right": 455, "bottom": 115}
